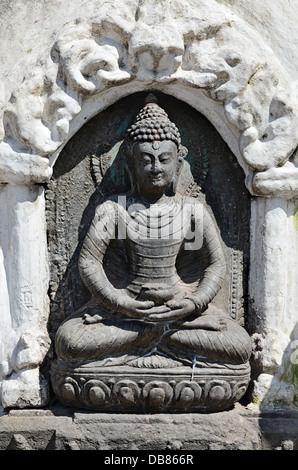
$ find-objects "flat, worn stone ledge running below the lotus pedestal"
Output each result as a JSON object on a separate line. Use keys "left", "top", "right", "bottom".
{"left": 0, "top": 404, "right": 298, "bottom": 452}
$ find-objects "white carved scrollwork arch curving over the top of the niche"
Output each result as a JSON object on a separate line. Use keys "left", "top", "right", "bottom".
{"left": 0, "top": 0, "right": 298, "bottom": 192}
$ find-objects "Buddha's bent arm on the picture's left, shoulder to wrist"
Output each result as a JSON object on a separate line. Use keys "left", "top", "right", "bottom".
{"left": 79, "top": 201, "right": 120, "bottom": 310}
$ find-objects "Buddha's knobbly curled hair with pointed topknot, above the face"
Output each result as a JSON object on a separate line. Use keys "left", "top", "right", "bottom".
{"left": 126, "top": 94, "right": 186, "bottom": 154}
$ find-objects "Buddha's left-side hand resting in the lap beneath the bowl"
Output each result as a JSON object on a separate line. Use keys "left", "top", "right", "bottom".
{"left": 117, "top": 297, "right": 170, "bottom": 321}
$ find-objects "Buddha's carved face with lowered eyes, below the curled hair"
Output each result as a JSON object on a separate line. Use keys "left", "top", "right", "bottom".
{"left": 132, "top": 140, "right": 178, "bottom": 199}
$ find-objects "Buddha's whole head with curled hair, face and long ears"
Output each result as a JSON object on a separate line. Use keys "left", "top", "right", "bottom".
{"left": 125, "top": 94, "right": 187, "bottom": 199}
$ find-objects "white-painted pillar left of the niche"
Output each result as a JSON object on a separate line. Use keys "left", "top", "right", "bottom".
{"left": 0, "top": 184, "right": 49, "bottom": 408}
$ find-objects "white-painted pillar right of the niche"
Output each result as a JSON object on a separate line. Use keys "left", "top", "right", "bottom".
{"left": 249, "top": 197, "right": 298, "bottom": 405}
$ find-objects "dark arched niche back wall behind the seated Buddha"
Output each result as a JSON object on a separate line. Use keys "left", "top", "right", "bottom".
{"left": 46, "top": 91, "right": 251, "bottom": 346}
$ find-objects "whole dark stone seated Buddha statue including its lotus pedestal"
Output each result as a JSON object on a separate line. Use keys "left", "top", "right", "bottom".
{"left": 52, "top": 99, "right": 251, "bottom": 411}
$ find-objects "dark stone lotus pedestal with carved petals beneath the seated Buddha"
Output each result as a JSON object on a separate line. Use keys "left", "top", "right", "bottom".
{"left": 51, "top": 361, "right": 250, "bottom": 412}
